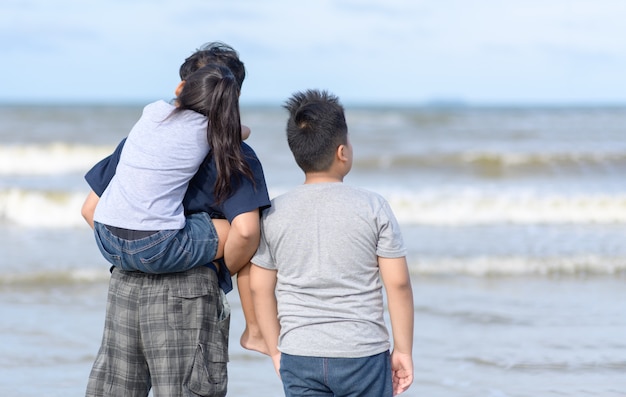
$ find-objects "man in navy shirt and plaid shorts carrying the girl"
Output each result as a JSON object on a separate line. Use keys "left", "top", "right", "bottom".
{"left": 82, "top": 43, "right": 269, "bottom": 397}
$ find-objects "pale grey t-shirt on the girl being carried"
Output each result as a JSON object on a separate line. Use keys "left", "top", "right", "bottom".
{"left": 94, "top": 101, "right": 209, "bottom": 230}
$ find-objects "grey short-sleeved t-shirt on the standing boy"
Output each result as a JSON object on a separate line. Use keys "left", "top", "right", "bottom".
{"left": 252, "top": 183, "right": 406, "bottom": 358}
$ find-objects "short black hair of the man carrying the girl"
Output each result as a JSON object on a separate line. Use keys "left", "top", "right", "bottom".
{"left": 179, "top": 41, "right": 246, "bottom": 89}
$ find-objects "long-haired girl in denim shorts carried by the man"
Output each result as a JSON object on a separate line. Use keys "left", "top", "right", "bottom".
{"left": 93, "top": 64, "right": 252, "bottom": 273}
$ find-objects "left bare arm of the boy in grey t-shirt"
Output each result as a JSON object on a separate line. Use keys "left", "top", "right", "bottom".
{"left": 250, "top": 263, "right": 280, "bottom": 377}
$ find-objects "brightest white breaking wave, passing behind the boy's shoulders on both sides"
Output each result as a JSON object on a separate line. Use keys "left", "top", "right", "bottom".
{"left": 0, "top": 188, "right": 626, "bottom": 228}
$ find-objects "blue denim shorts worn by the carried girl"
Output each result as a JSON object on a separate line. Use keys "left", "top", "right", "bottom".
{"left": 94, "top": 212, "right": 219, "bottom": 274}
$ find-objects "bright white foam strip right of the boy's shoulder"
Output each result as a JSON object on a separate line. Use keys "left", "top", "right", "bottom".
{"left": 387, "top": 188, "right": 626, "bottom": 226}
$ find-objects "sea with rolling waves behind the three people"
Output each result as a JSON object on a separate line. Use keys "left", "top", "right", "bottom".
{"left": 0, "top": 104, "right": 626, "bottom": 397}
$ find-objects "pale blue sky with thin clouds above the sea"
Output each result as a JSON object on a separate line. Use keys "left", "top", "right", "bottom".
{"left": 0, "top": 0, "right": 626, "bottom": 105}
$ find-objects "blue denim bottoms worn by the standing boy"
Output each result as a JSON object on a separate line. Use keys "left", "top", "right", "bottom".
{"left": 280, "top": 351, "right": 393, "bottom": 397}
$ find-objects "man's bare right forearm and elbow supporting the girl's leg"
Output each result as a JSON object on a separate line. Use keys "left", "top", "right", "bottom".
{"left": 224, "top": 208, "right": 261, "bottom": 274}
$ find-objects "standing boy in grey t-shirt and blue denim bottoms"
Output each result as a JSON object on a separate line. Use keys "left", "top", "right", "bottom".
{"left": 250, "top": 90, "right": 413, "bottom": 397}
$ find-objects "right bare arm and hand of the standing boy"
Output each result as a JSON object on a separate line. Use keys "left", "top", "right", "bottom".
{"left": 378, "top": 257, "right": 414, "bottom": 395}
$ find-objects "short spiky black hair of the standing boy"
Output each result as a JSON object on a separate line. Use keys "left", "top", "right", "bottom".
{"left": 284, "top": 90, "right": 348, "bottom": 172}
